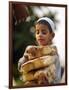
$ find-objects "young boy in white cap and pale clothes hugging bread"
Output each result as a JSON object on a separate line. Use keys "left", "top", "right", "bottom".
{"left": 18, "top": 17, "right": 61, "bottom": 86}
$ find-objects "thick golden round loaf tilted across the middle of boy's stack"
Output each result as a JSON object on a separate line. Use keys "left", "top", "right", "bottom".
{"left": 21, "top": 56, "right": 56, "bottom": 72}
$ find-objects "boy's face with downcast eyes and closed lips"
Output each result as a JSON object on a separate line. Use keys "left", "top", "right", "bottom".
{"left": 35, "top": 24, "right": 53, "bottom": 46}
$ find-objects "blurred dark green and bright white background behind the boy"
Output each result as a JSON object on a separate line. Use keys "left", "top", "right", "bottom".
{"left": 12, "top": 3, "right": 65, "bottom": 86}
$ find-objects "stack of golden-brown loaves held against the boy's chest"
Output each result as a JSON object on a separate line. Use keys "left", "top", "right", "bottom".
{"left": 21, "top": 46, "right": 57, "bottom": 82}
